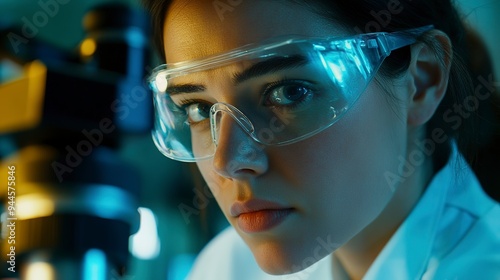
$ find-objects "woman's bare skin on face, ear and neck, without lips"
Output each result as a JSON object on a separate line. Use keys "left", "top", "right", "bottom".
{"left": 164, "top": 0, "right": 446, "bottom": 279}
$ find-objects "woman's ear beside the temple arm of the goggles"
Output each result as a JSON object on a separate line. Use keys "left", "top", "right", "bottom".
{"left": 408, "top": 30, "right": 452, "bottom": 126}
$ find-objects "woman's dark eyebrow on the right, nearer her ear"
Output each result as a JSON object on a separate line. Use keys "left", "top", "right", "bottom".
{"left": 233, "top": 55, "right": 308, "bottom": 85}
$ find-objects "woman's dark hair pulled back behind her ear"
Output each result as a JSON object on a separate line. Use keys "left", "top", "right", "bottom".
{"left": 143, "top": 0, "right": 500, "bottom": 200}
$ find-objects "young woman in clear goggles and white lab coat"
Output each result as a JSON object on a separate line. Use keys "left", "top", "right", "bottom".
{"left": 143, "top": 0, "right": 500, "bottom": 279}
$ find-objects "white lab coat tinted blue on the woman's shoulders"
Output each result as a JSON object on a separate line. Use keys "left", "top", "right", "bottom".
{"left": 188, "top": 149, "right": 500, "bottom": 280}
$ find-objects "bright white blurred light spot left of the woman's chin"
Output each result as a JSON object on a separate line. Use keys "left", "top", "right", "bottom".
{"left": 129, "top": 207, "right": 161, "bottom": 260}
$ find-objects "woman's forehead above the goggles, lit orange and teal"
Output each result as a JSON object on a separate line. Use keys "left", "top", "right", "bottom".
{"left": 164, "top": 0, "right": 345, "bottom": 63}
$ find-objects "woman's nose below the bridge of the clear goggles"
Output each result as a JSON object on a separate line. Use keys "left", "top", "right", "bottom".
{"left": 213, "top": 112, "right": 268, "bottom": 179}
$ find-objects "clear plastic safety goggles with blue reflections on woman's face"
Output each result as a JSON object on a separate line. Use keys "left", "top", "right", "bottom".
{"left": 148, "top": 26, "right": 433, "bottom": 162}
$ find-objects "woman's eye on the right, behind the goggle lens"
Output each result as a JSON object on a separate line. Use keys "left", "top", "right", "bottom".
{"left": 266, "top": 81, "right": 313, "bottom": 106}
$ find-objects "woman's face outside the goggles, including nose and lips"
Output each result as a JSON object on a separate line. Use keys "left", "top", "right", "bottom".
{"left": 164, "top": 0, "right": 407, "bottom": 274}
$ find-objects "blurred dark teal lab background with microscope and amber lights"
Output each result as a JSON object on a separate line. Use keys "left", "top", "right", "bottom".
{"left": 0, "top": 0, "right": 500, "bottom": 280}
